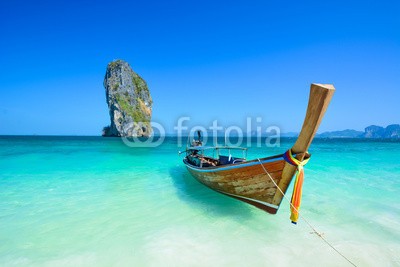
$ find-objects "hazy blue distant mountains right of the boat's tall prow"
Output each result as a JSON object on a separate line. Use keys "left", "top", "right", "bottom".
{"left": 316, "top": 124, "right": 400, "bottom": 139}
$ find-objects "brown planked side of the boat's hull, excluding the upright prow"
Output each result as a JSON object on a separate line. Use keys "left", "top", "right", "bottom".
{"left": 183, "top": 155, "right": 285, "bottom": 214}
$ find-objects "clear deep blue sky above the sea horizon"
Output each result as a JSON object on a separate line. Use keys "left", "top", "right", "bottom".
{"left": 0, "top": 0, "right": 400, "bottom": 135}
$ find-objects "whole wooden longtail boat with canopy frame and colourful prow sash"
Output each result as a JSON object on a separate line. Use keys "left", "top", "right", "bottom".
{"left": 180, "top": 84, "right": 335, "bottom": 223}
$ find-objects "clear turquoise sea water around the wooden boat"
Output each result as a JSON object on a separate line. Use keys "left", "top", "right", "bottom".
{"left": 0, "top": 137, "right": 400, "bottom": 266}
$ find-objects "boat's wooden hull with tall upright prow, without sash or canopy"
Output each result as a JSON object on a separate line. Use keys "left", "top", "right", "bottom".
{"left": 183, "top": 84, "right": 335, "bottom": 217}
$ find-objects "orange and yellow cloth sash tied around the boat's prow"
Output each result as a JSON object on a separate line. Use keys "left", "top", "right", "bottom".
{"left": 283, "top": 149, "right": 310, "bottom": 224}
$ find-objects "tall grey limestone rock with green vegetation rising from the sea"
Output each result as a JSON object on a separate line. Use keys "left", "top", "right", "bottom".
{"left": 103, "top": 59, "right": 153, "bottom": 137}
